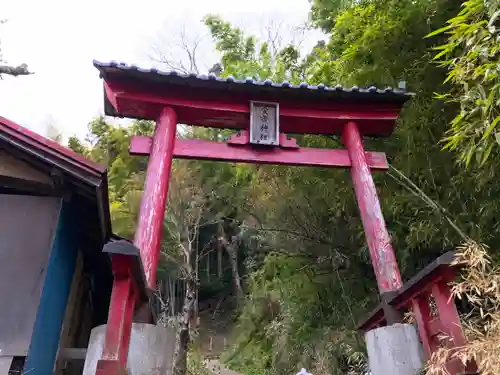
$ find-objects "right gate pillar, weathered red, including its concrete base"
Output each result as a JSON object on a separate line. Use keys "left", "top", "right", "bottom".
{"left": 342, "top": 121, "right": 424, "bottom": 375}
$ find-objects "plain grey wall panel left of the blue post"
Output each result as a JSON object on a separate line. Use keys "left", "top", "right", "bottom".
{"left": 0, "top": 195, "right": 61, "bottom": 366}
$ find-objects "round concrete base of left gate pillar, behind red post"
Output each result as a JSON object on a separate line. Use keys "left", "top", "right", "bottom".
{"left": 83, "top": 323, "right": 175, "bottom": 375}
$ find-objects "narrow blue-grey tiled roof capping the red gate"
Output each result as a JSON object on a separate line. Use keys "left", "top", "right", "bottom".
{"left": 94, "top": 60, "right": 414, "bottom": 102}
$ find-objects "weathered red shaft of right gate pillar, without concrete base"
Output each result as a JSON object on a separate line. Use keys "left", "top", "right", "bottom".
{"left": 343, "top": 121, "right": 403, "bottom": 293}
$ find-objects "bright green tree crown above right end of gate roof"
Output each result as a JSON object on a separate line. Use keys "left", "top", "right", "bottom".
{"left": 315, "top": 0, "right": 457, "bottom": 87}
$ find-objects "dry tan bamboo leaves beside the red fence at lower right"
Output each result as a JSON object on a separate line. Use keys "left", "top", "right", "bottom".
{"left": 426, "top": 241, "right": 500, "bottom": 375}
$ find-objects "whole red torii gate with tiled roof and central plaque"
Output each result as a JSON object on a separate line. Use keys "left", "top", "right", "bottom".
{"left": 94, "top": 62, "right": 468, "bottom": 375}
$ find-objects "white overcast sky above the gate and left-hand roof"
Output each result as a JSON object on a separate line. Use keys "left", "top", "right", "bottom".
{"left": 0, "top": 0, "right": 324, "bottom": 141}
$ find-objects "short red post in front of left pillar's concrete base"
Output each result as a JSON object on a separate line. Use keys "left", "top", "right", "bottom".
{"left": 96, "top": 254, "right": 137, "bottom": 375}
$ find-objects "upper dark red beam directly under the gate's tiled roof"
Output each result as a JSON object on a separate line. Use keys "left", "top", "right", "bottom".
{"left": 105, "top": 81, "right": 401, "bottom": 136}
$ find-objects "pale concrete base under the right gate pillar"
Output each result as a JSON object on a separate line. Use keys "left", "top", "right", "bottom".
{"left": 365, "top": 324, "right": 424, "bottom": 375}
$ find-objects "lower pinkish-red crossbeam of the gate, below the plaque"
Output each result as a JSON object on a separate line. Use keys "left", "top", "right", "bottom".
{"left": 130, "top": 136, "right": 388, "bottom": 170}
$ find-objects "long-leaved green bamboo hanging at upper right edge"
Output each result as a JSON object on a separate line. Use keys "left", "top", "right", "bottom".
{"left": 429, "top": 0, "right": 500, "bottom": 166}
